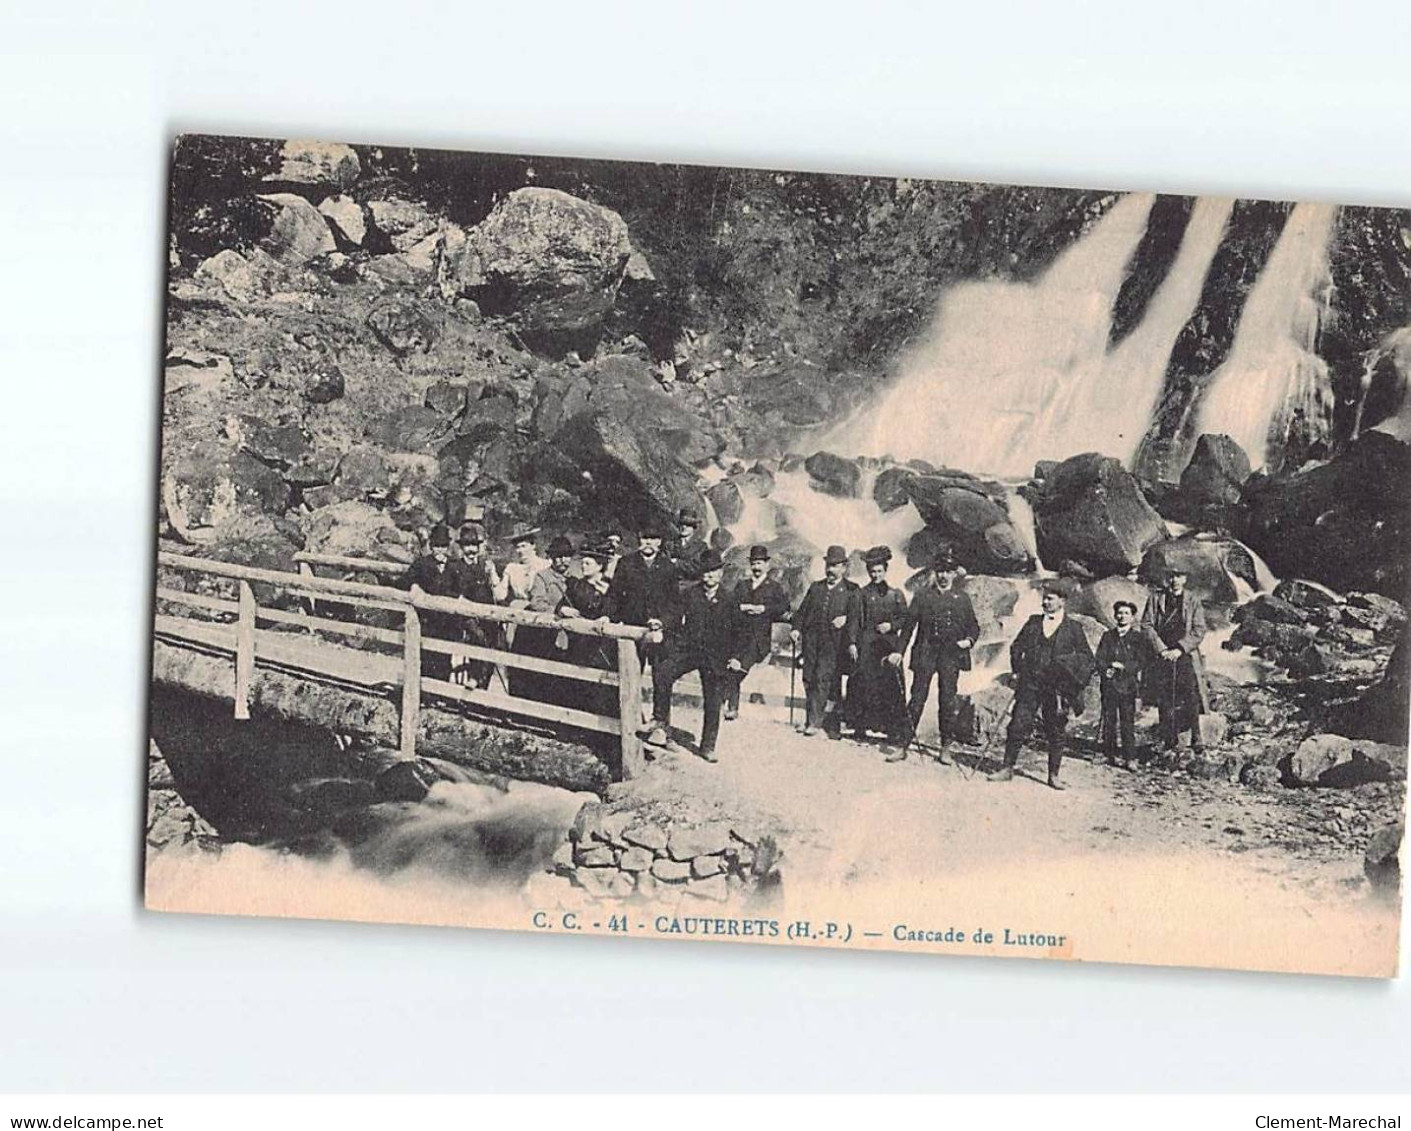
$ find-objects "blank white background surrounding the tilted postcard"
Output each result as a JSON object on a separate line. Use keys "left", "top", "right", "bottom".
{"left": 0, "top": 0, "right": 1411, "bottom": 1094}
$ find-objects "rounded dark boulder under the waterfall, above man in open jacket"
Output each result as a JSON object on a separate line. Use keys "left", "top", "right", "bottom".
{"left": 1026, "top": 451, "right": 1170, "bottom": 577}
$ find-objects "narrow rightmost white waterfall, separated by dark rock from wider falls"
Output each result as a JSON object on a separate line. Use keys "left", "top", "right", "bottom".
{"left": 1198, "top": 204, "right": 1338, "bottom": 468}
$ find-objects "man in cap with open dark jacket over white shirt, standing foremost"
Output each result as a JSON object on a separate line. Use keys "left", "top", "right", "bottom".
{"left": 989, "top": 581, "right": 1092, "bottom": 790}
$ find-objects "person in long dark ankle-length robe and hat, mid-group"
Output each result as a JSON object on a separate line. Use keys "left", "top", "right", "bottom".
{"left": 848, "top": 546, "right": 912, "bottom": 762}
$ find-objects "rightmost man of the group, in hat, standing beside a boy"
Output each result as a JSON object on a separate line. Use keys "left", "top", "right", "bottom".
{"left": 1141, "top": 568, "right": 1209, "bottom": 753}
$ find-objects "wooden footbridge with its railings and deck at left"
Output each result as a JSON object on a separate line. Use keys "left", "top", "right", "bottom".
{"left": 155, "top": 551, "right": 648, "bottom": 777}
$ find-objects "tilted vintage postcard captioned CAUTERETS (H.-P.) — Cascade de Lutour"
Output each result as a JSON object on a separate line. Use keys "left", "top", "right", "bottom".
{"left": 145, "top": 135, "right": 1411, "bottom": 977}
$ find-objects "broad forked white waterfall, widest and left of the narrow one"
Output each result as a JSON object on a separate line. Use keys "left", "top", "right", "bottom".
{"left": 818, "top": 193, "right": 1233, "bottom": 478}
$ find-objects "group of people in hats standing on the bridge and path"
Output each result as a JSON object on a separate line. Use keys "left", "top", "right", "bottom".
{"left": 404, "top": 511, "right": 1206, "bottom": 790}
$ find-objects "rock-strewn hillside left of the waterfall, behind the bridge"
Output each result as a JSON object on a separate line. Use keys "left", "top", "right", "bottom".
{"left": 161, "top": 137, "right": 1110, "bottom": 566}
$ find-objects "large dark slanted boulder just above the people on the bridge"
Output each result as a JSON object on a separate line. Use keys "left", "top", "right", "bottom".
{"left": 553, "top": 409, "right": 706, "bottom": 523}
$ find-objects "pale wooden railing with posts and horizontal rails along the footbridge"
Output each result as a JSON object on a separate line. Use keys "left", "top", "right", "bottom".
{"left": 157, "top": 551, "right": 648, "bottom": 777}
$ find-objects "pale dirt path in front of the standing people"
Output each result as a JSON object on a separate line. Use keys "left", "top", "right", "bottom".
{"left": 629, "top": 705, "right": 1400, "bottom": 973}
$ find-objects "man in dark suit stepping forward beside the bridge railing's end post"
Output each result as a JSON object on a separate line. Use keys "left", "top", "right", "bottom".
{"left": 646, "top": 550, "right": 745, "bottom": 762}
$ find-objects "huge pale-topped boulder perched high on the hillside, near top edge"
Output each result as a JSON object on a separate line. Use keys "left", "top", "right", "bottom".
{"left": 443, "top": 188, "right": 641, "bottom": 353}
